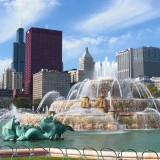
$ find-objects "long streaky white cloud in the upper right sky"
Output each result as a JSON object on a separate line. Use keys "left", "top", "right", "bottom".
{"left": 76, "top": 0, "right": 160, "bottom": 33}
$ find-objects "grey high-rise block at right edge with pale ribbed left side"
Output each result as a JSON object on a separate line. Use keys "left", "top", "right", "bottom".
{"left": 116, "top": 47, "right": 160, "bottom": 79}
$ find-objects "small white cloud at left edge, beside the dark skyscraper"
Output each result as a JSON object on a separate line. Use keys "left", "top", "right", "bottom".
{"left": 0, "top": 59, "right": 12, "bottom": 81}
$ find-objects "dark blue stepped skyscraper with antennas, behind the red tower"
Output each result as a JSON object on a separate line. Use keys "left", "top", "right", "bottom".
{"left": 12, "top": 28, "right": 25, "bottom": 84}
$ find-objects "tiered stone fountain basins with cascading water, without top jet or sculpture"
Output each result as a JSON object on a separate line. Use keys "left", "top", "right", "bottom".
{"left": 49, "top": 78, "right": 160, "bottom": 130}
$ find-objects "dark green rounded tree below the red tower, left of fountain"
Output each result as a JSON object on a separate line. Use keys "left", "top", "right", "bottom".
{"left": 13, "top": 97, "right": 31, "bottom": 108}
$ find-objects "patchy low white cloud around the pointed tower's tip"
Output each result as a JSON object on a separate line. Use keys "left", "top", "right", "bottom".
{"left": 63, "top": 33, "right": 132, "bottom": 63}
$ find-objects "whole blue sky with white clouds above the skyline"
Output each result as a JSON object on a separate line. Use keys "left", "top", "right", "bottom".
{"left": 0, "top": 0, "right": 160, "bottom": 79}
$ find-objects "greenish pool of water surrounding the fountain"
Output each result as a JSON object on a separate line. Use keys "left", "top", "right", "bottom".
{"left": 0, "top": 119, "right": 160, "bottom": 152}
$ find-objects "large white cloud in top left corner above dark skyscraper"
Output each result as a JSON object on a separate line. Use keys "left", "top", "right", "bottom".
{"left": 0, "top": 0, "right": 59, "bottom": 42}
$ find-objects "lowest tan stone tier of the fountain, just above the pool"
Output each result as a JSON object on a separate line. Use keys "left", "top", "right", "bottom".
{"left": 13, "top": 109, "right": 160, "bottom": 131}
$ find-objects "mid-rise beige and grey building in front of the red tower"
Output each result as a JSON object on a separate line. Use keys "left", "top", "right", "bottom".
{"left": 33, "top": 69, "right": 70, "bottom": 100}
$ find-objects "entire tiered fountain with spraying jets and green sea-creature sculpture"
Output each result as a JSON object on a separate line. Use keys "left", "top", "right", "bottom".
{"left": 0, "top": 58, "right": 160, "bottom": 149}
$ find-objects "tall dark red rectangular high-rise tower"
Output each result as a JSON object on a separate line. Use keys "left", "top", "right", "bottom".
{"left": 24, "top": 28, "right": 63, "bottom": 95}
